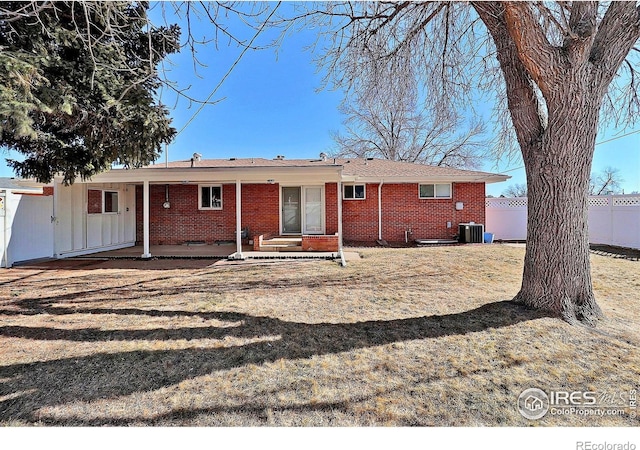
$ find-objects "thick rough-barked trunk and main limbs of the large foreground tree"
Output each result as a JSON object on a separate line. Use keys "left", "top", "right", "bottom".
{"left": 472, "top": 2, "right": 640, "bottom": 325}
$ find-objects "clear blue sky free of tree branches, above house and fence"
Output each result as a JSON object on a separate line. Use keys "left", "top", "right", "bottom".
{"left": 0, "top": 2, "right": 640, "bottom": 196}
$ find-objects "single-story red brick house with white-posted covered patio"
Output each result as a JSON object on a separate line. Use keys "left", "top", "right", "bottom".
{"left": 45, "top": 154, "right": 508, "bottom": 257}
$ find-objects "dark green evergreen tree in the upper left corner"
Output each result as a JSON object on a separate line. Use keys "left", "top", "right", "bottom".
{"left": 0, "top": 2, "right": 180, "bottom": 183}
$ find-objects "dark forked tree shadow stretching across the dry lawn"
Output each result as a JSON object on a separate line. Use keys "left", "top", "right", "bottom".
{"left": 0, "top": 301, "right": 545, "bottom": 425}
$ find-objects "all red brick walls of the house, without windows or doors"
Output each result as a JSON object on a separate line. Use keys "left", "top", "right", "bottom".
{"left": 134, "top": 183, "right": 485, "bottom": 245}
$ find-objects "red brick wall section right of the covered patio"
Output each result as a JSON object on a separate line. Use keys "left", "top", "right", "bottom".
{"left": 342, "top": 183, "right": 485, "bottom": 242}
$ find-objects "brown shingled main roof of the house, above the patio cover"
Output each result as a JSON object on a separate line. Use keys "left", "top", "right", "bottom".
{"left": 147, "top": 158, "right": 509, "bottom": 183}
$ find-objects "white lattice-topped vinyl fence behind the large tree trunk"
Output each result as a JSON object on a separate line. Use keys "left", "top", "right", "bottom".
{"left": 485, "top": 194, "right": 640, "bottom": 249}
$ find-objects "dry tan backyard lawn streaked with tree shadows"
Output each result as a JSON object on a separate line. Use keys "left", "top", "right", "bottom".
{"left": 0, "top": 245, "right": 640, "bottom": 426}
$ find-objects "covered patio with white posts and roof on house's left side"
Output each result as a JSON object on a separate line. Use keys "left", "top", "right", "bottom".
{"left": 54, "top": 155, "right": 341, "bottom": 259}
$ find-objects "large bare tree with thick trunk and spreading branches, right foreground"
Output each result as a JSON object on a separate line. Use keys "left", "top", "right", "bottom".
{"left": 280, "top": 2, "right": 640, "bottom": 325}
